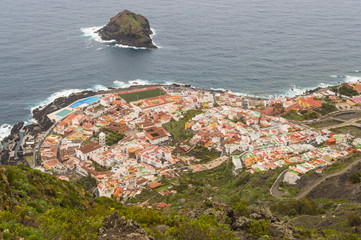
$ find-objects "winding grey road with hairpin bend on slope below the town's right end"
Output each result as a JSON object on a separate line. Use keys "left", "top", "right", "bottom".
{"left": 270, "top": 159, "right": 361, "bottom": 200}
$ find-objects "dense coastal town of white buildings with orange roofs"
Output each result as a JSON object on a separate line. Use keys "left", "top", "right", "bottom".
{"left": 28, "top": 83, "right": 361, "bottom": 201}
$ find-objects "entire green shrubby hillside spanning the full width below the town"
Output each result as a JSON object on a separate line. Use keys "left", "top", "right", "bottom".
{"left": 0, "top": 162, "right": 361, "bottom": 240}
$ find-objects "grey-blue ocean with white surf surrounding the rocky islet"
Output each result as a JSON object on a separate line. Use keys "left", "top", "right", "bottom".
{"left": 0, "top": 0, "right": 361, "bottom": 139}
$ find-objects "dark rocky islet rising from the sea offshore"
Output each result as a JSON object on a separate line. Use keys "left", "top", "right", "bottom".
{"left": 98, "top": 10, "right": 157, "bottom": 49}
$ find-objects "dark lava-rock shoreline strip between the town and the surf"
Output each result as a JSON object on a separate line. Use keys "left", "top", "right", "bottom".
{"left": 0, "top": 83, "right": 332, "bottom": 165}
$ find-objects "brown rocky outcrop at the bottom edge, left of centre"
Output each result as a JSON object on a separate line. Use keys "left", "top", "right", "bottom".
{"left": 99, "top": 211, "right": 153, "bottom": 240}
